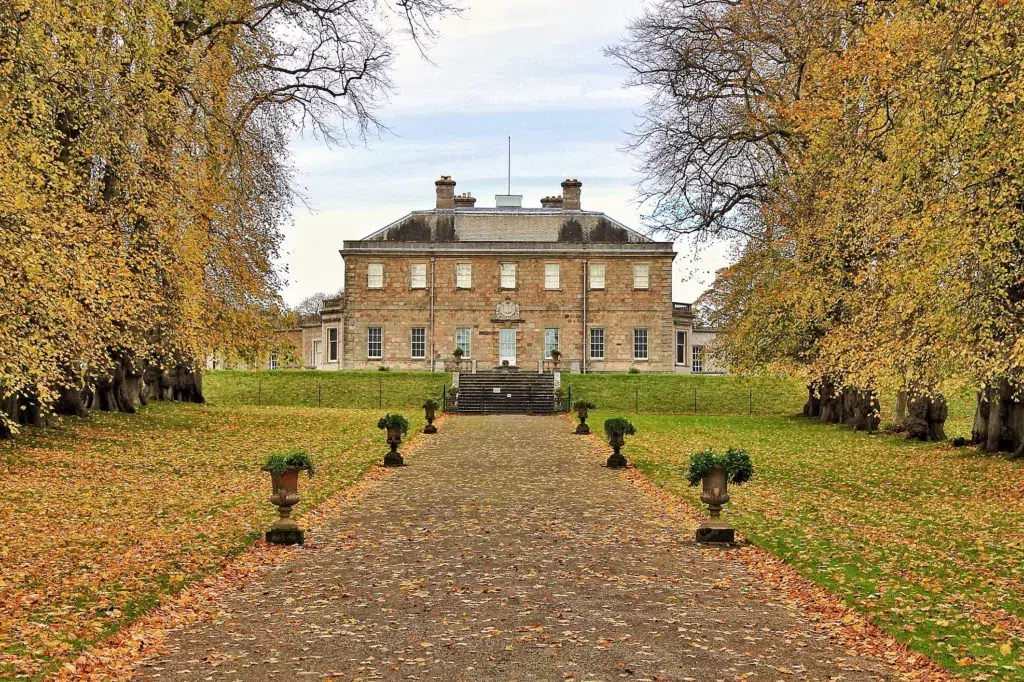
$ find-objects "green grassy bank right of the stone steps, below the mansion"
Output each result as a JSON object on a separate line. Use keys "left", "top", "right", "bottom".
{"left": 562, "top": 374, "right": 974, "bottom": 421}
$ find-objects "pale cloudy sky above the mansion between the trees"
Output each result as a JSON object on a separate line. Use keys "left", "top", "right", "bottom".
{"left": 283, "top": 0, "right": 725, "bottom": 304}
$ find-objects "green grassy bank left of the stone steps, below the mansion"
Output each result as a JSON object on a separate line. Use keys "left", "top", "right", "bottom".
{"left": 203, "top": 370, "right": 452, "bottom": 410}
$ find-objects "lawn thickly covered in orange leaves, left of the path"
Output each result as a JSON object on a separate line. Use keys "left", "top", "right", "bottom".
{"left": 0, "top": 404, "right": 422, "bottom": 679}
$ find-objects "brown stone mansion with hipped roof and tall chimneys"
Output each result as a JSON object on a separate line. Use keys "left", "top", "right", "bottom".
{"left": 288, "top": 175, "right": 718, "bottom": 373}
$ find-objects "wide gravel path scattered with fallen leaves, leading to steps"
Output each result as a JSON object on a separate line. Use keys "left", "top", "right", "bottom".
{"left": 140, "top": 416, "right": 888, "bottom": 682}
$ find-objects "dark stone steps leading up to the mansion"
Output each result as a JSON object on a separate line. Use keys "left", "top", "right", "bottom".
{"left": 455, "top": 371, "right": 561, "bottom": 415}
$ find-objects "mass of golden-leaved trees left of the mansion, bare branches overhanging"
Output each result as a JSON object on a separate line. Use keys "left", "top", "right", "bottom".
{"left": 0, "top": 0, "right": 455, "bottom": 435}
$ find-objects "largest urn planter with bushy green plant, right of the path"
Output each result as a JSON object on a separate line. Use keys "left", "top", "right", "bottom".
{"left": 686, "top": 447, "right": 754, "bottom": 543}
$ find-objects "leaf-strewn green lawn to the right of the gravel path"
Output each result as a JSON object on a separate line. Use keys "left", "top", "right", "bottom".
{"left": 606, "top": 414, "right": 1024, "bottom": 680}
